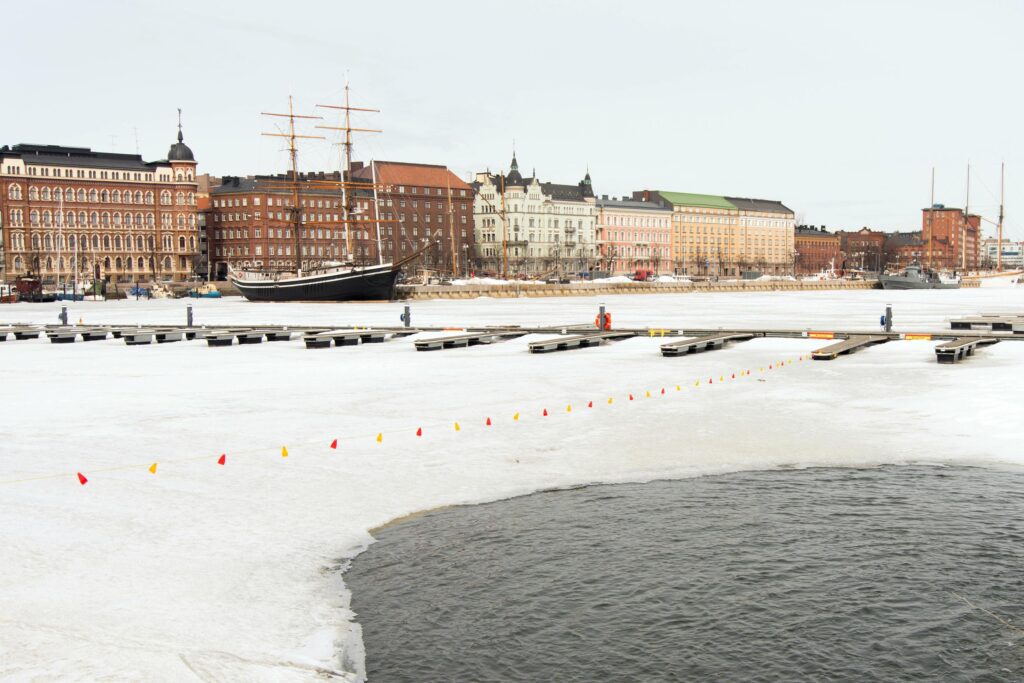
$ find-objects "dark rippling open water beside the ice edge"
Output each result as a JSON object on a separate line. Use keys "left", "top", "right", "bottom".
{"left": 345, "top": 466, "right": 1024, "bottom": 683}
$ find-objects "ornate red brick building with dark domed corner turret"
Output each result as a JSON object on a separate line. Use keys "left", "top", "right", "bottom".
{"left": 0, "top": 125, "right": 199, "bottom": 283}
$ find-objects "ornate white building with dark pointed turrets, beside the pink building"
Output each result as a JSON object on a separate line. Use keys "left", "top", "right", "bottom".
{"left": 473, "top": 154, "right": 600, "bottom": 276}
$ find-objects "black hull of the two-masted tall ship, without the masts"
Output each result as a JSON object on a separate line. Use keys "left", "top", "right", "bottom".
{"left": 231, "top": 263, "right": 400, "bottom": 301}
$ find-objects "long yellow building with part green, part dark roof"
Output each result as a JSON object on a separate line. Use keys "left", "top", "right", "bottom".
{"left": 633, "top": 190, "right": 796, "bottom": 278}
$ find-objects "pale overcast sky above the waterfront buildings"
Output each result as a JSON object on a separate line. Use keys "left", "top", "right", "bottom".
{"left": 0, "top": 0, "right": 1024, "bottom": 240}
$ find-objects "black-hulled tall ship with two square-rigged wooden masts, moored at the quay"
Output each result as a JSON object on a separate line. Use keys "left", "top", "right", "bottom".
{"left": 228, "top": 84, "right": 434, "bottom": 301}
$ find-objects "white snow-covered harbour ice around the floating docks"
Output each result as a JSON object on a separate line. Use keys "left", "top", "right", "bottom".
{"left": 0, "top": 283, "right": 1024, "bottom": 680}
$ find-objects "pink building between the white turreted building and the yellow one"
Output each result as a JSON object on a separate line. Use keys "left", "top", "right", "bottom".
{"left": 597, "top": 195, "right": 675, "bottom": 275}
